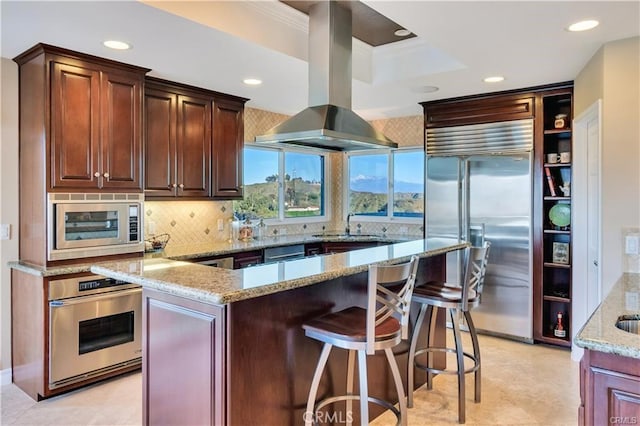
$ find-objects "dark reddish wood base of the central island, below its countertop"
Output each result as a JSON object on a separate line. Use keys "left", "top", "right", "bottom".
{"left": 143, "top": 255, "right": 446, "bottom": 426}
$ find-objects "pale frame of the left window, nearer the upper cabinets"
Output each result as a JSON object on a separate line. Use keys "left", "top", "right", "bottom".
{"left": 239, "top": 142, "right": 331, "bottom": 225}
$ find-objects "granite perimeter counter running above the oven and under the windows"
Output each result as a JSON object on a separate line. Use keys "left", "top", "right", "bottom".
{"left": 7, "top": 232, "right": 422, "bottom": 277}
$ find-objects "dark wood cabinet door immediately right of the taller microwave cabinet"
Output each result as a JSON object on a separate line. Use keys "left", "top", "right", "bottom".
{"left": 144, "top": 89, "right": 177, "bottom": 197}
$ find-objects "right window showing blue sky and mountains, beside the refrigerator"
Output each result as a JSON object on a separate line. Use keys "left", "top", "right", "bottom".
{"left": 346, "top": 149, "right": 424, "bottom": 221}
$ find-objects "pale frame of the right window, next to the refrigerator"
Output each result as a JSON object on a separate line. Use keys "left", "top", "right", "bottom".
{"left": 342, "top": 146, "right": 426, "bottom": 225}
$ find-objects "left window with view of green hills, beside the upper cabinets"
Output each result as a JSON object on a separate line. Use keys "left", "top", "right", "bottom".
{"left": 233, "top": 146, "right": 325, "bottom": 220}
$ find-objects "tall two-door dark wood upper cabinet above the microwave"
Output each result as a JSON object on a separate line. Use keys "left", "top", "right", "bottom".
{"left": 42, "top": 48, "right": 146, "bottom": 191}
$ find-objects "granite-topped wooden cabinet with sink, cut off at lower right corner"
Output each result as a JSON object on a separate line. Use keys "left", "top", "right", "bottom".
{"left": 575, "top": 273, "right": 640, "bottom": 425}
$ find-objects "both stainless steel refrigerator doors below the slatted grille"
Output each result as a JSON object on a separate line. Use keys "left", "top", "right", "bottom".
{"left": 426, "top": 152, "right": 533, "bottom": 341}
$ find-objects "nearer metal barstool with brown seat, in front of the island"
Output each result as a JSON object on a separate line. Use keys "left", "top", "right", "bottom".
{"left": 303, "top": 256, "right": 418, "bottom": 426}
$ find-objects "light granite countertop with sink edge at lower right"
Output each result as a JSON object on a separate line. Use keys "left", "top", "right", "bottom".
{"left": 575, "top": 273, "right": 640, "bottom": 358}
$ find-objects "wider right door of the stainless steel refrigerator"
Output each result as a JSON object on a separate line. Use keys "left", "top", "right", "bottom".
{"left": 467, "top": 153, "right": 533, "bottom": 340}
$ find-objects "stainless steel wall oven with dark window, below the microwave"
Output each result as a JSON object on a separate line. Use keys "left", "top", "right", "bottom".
{"left": 49, "top": 275, "right": 142, "bottom": 389}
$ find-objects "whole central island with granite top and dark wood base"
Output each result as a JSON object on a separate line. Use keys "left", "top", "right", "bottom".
{"left": 91, "top": 239, "right": 467, "bottom": 425}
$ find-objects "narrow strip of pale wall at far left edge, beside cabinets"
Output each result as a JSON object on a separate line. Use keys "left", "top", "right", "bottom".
{"left": 0, "top": 58, "right": 18, "bottom": 376}
